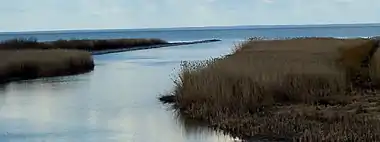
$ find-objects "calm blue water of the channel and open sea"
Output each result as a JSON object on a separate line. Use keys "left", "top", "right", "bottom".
{"left": 0, "top": 27, "right": 380, "bottom": 142}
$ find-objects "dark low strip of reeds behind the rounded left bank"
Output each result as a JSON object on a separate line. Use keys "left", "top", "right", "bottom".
{"left": 0, "top": 39, "right": 167, "bottom": 51}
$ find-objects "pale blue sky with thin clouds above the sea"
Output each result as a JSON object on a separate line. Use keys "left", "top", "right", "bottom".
{"left": 0, "top": 0, "right": 380, "bottom": 32}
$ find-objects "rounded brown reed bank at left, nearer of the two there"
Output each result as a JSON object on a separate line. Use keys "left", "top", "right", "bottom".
{"left": 0, "top": 49, "right": 94, "bottom": 83}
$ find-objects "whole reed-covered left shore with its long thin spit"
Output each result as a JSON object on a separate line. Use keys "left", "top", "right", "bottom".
{"left": 0, "top": 39, "right": 220, "bottom": 83}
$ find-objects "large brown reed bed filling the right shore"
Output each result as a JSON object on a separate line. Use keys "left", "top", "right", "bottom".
{"left": 160, "top": 38, "right": 380, "bottom": 141}
